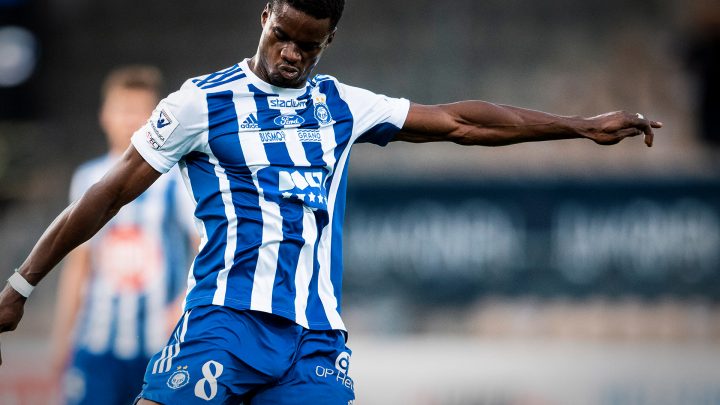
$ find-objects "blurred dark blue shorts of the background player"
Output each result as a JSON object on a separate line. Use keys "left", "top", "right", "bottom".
{"left": 63, "top": 349, "right": 148, "bottom": 405}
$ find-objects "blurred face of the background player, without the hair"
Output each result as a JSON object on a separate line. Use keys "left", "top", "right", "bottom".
{"left": 100, "top": 87, "right": 158, "bottom": 153}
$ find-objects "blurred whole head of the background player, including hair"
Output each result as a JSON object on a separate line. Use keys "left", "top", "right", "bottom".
{"left": 100, "top": 65, "right": 163, "bottom": 153}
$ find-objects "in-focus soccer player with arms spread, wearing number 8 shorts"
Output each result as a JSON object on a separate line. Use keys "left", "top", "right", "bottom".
{"left": 0, "top": 0, "right": 661, "bottom": 405}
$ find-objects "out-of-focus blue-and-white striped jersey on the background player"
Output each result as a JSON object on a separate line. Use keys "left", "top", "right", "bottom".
{"left": 70, "top": 155, "right": 197, "bottom": 359}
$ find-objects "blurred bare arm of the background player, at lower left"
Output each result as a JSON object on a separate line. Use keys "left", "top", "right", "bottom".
{"left": 52, "top": 244, "right": 90, "bottom": 378}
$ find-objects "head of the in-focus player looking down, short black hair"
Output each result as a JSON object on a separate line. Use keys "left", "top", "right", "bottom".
{"left": 253, "top": 0, "right": 345, "bottom": 88}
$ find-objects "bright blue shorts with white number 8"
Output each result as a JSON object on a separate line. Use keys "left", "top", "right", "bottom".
{"left": 138, "top": 306, "right": 355, "bottom": 405}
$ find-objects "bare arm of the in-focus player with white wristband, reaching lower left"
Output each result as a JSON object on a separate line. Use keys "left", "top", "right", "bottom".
{"left": 0, "top": 145, "right": 160, "bottom": 364}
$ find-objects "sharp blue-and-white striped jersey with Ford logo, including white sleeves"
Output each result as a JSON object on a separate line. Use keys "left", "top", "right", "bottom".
{"left": 133, "top": 60, "right": 410, "bottom": 330}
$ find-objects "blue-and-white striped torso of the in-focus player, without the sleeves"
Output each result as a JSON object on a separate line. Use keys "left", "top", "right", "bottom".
{"left": 180, "top": 68, "right": 352, "bottom": 328}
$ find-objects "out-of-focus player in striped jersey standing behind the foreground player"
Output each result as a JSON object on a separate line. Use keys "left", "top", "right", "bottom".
{"left": 53, "top": 66, "right": 194, "bottom": 404}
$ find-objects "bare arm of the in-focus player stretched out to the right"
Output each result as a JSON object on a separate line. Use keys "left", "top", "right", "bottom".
{"left": 395, "top": 101, "right": 662, "bottom": 146}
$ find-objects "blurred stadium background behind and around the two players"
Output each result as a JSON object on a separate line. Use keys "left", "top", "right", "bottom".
{"left": 0, "top": 0, "right": 720, "bottom": 405}
